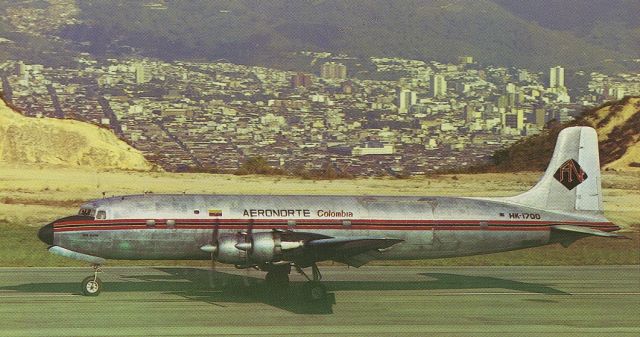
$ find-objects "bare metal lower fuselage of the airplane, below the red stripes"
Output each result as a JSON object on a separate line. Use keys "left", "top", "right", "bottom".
{"left": 57, "top": 229, "right": 549, "bottom": 260}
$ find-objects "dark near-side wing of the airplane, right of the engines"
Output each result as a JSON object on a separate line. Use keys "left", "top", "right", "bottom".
{"left": 306, "top": 236, "right": 404, "bottom": 267}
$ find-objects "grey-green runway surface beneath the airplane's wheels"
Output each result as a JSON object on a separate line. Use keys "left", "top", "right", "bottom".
{"left": 0, "top": 266, "right": 640, "bottom": 336}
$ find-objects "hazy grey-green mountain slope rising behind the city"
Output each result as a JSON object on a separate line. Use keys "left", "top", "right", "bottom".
{"left": 53, "top": 0, "right": 640, "bottom": 70}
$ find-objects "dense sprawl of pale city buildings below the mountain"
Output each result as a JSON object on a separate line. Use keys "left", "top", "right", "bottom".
{"left": 0, "top": 52, "right": 640, "bottom": 176}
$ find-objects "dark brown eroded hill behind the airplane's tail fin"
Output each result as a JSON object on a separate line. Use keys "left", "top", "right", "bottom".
{"left": 490, "top": 96, "right": 640, "bottom": 171}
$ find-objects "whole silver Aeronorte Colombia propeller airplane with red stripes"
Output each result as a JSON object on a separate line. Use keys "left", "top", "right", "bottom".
{"left": 38, "top": 127, "right": 624, "bottom": 301}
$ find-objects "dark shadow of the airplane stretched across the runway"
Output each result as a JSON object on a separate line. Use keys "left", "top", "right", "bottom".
{"left": 0, "top": 268, "right": 568, "bottom": 314}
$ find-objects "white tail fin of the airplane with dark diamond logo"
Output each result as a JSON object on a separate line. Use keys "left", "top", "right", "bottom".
{"left": 507, "top": 126, "right": 603, "bottom": 212}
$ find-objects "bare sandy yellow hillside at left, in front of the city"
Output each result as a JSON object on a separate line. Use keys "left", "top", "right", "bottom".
{"left": 0, "top": 100, "right": 153, "bottom": 171}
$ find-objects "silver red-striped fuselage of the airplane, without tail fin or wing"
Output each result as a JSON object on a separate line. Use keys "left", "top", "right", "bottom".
{"left": 53, "top": 194, "right": 618, "bottom": 259}
